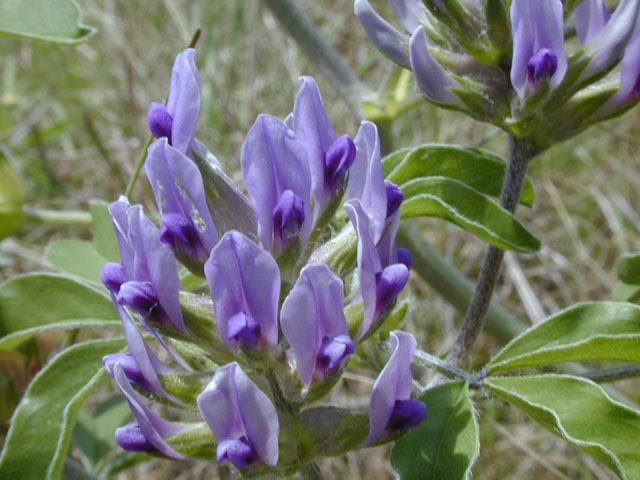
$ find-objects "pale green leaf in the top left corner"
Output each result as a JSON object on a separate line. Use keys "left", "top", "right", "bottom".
{"left": 0, "top": 0, "right": 94, "bottom": 44}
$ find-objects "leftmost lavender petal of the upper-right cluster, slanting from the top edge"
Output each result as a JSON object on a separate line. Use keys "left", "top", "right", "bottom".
{"left": 353, "top": 0, "right": 411, "bottom": 69}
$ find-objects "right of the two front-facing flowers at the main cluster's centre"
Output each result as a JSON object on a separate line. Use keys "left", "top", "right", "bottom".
{"left": 280, "top": 264, "right": 355, "bottom": 386}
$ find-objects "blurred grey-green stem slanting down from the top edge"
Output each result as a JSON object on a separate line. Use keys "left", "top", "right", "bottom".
{"left": 263, "top": 0, "right": 366, "bottom": 118}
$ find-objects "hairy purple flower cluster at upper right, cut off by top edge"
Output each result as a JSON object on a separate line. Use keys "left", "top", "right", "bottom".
{"left": 354, "top": 0, "right": 640, "bottom": 148}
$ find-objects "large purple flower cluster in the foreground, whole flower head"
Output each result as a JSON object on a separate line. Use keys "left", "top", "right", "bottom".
{"left": 101, "top": 49, "right": 426, "bottom": 470}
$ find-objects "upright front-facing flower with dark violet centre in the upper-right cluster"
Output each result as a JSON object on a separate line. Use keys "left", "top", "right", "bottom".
{"left": 511, "top": 0, "right": 567, "bottom": 98}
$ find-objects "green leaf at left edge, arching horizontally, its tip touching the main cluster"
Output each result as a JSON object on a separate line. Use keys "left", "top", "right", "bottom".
{"left": 0, "top": 273, "right": 118, "bottom": 337}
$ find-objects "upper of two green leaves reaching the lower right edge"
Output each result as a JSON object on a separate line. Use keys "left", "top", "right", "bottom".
{"left": 487, "top": 302, "right": 640, "bottom": 373}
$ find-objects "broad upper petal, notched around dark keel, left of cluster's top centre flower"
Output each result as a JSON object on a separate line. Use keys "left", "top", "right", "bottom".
{"left": 241, "top": 115, "right": 313, "bottom": 255}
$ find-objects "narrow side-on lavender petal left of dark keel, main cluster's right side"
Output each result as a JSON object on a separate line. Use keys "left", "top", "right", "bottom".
{"left": 344, "top": 200, "right": 382, "bottom": 338}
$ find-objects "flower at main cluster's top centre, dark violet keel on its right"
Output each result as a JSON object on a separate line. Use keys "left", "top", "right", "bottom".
{"left": 292, "top": 76, "right": 355, "bottom": 213}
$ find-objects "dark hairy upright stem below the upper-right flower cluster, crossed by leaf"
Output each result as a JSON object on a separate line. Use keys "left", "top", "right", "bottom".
{"left": 447, "top": 136, "right": 537, "bottom": 366}
